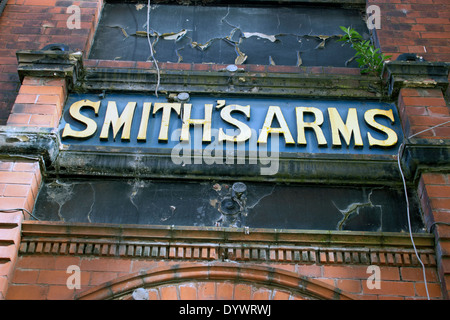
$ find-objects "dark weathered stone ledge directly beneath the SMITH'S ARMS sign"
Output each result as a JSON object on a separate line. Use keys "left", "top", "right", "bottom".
{"left": 54, "top": 145, "right": 400, "bottom": 184}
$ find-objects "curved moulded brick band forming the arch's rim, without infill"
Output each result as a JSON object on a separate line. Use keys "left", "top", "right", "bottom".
{"left": 75, "top": 262, "right": 354, "bottom": 300}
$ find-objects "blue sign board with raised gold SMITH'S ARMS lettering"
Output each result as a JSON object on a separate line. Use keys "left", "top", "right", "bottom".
{"left": 60, "top": 94, "right": 402, "bottom": 155}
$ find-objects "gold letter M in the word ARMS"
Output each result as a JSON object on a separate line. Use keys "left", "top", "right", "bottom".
{"left": 328, "top": 108, "right": 363, "bottom": 147}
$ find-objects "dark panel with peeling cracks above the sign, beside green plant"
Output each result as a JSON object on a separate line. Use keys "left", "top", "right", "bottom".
{"left": 90, "top": 3, "right": 369, "bottom": 67}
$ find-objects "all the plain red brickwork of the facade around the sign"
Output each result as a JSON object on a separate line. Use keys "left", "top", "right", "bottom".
{"left": 0, "top": 0, "right": 450, "bottom": 299}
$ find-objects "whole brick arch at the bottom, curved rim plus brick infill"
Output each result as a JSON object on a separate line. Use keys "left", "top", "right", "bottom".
{"left": 75, "top": 262, "right": 354, "bottom": 300}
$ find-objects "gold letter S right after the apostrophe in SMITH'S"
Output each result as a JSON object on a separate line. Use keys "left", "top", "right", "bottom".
{"left": 219, "top": 104, "right": 252, "bottom": 143}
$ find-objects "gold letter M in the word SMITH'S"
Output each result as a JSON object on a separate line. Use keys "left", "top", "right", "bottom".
{"left": 100, "top": 101, "right": 136, "bottom": 140}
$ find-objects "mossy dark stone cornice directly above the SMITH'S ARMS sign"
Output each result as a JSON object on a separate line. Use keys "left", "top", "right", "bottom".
{"left": 77, "top": 68, "right": 382, "bottom": 99}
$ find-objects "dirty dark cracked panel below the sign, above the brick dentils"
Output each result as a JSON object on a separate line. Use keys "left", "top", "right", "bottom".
{"left": 34, "top": 178, "right": 424, "bottom": 232}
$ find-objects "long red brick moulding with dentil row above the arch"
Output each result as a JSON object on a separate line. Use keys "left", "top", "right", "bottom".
{"left": 19, "top": 221, "right": 436, "bottom": 266}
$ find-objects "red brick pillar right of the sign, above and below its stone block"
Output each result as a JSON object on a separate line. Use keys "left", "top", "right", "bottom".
{"left": 398, "top": 88, "right": 450, "bottom": 299}
